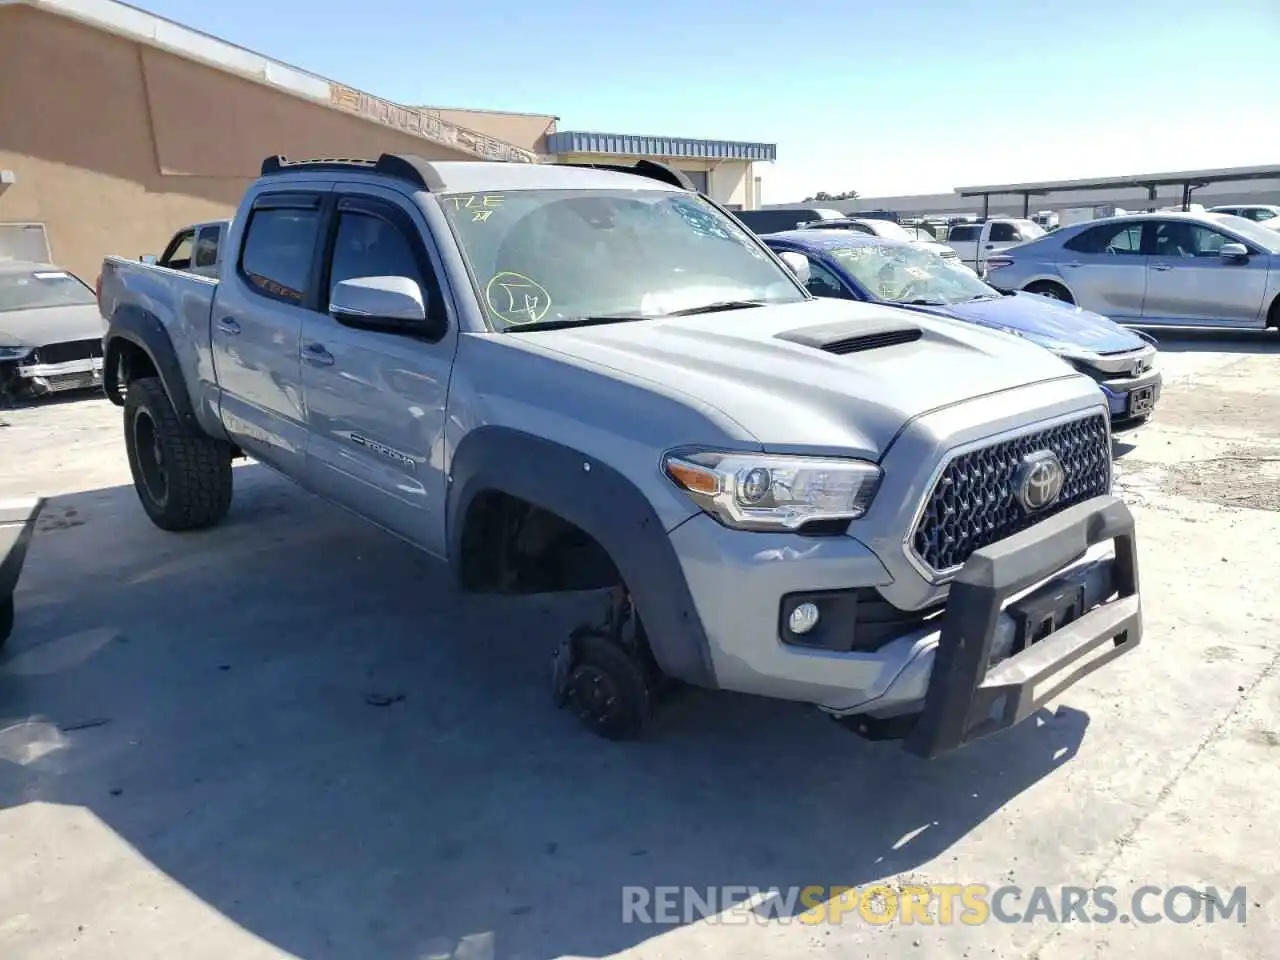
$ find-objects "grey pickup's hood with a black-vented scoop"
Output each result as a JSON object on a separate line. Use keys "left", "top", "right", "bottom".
{"left": 519, "top": 300, "right": 1075, "bottom": 458}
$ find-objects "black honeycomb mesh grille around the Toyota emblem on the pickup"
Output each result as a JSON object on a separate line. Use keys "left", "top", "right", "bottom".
{"left": 911, "top": 415, "right": 1111, "bottom": 572}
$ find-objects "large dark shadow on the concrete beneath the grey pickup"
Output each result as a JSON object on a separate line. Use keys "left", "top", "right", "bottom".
{"left": 0, "top": 466, "right": 1088, "bottom": 960}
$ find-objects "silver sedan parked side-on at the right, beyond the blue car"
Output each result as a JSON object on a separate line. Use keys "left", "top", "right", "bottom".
{"left": 987, "top": 212, "right": 1280, "bottom": 329}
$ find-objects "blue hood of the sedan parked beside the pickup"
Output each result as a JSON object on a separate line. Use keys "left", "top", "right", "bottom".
{"left": 906, "top": 293, "right": 1146, "bottom": 353}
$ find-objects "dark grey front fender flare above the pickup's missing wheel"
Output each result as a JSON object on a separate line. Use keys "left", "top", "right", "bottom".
{"left": 445, "top": 426, "right": 716, "bottom": 689}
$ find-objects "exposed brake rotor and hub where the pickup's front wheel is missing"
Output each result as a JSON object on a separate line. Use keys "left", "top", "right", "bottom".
{"left": 568, "top": 636, "right": 653, "bottom": 740}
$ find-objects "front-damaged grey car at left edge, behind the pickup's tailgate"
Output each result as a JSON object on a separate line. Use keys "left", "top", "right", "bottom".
{"left": 0, "top": 260, "right": 102, "bottom": 403}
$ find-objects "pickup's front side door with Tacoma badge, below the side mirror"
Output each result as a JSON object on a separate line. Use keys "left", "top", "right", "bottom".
{"left": 301, "top": 184, "right": 457, "bottom": 556}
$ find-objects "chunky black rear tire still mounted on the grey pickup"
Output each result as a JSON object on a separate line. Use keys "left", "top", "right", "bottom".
{"left": 124, "top": 376, "right": 232, "bottom": 531}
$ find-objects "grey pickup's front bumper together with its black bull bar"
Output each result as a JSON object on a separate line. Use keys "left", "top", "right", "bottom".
{"left": 672, "top": 495, "right": 1142, "bottom": 756}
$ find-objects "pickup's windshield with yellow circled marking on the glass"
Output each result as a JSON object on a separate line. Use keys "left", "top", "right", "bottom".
{"left": 440, "top": 189, "right": 806, "bottom": 330}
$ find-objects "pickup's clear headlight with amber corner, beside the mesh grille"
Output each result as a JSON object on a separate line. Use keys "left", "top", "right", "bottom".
{"left": 662, "top": 452, "right": 882, "bottom": 530}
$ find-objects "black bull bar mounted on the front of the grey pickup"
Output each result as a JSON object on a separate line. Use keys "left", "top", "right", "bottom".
{"left": 904, "top": 495, "right": 1142, "bottom": 758}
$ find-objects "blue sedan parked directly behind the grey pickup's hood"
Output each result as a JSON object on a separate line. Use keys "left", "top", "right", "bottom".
{"left": 760, "top": 230, "right": 1162, "bottom": 422}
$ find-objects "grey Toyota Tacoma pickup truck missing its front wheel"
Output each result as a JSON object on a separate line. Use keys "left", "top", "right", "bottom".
{"left": 100, "top": 155, "right": 1142, "bottom": 756}
